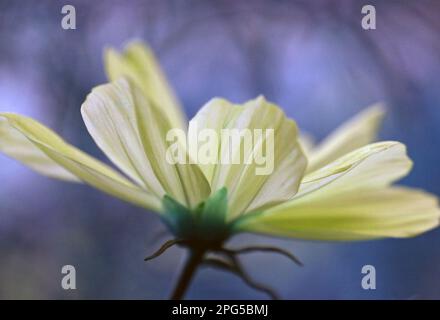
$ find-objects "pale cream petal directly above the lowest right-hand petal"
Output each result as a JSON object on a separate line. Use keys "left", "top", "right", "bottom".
{"left": 296, "top": 141, "right": 412, "bottom": 199}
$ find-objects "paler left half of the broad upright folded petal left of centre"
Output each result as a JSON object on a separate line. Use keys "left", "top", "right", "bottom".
{"left": 81, "top": 79, "right": 165, "bottom": 198}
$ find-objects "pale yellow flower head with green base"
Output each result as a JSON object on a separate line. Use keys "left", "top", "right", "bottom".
{"left": 0, "top": 43, "right": 440, "bottom": 298}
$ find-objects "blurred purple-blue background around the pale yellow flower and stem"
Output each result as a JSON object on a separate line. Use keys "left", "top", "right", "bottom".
{"left": 0, "top": 0, "right": 440, "bottom": 299}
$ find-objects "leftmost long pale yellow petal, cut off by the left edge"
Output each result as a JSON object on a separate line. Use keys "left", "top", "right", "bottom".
{"left": 0, "top": 113, "right": 161, "bottom": 211}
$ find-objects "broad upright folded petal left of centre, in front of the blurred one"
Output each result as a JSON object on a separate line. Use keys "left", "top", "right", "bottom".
{"left": 81, "top": 78, "right": 210, "bottom": 207}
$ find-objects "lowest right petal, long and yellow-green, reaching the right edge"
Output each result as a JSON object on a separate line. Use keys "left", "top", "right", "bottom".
{"left": 237, "top": 187, "right": 440, "bottom": 241}
